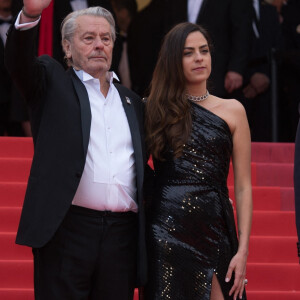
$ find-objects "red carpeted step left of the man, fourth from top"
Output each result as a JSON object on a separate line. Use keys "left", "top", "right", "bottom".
{"left": 0, "top": 207, "right": 21, "bottom": 232}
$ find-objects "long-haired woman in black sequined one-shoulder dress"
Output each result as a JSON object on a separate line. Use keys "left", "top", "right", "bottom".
{"left": 145, "top": 23, "right": 252, "bottom": 300}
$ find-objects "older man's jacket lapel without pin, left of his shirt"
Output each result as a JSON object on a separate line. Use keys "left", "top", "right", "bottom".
{"left": 67, "top": 68, "right": 92, "bottom": 157}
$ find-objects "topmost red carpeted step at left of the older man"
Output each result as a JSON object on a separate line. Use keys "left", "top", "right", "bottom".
{"left": 0, "top": 137, "right": 33, "bottom": 158}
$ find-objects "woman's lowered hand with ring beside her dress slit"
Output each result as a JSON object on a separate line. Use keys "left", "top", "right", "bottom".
{"left": 225, "top": 252, "right": 247, "bottom": 300}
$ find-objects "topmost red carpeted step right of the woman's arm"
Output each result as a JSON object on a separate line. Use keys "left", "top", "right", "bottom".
{"left": 251, "top": 143, "right": 300, "bottom": 163}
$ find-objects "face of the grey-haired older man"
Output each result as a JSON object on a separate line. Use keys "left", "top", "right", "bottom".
{"left": 64, "top": 16, "right": 114, "bottom": 78}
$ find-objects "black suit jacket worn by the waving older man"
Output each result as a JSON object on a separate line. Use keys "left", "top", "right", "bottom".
{"left": 5, "top": 21, "right": 146, "bottom": 285}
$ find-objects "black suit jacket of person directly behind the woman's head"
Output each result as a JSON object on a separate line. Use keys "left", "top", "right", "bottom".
{"left": 128, "top": 0, "right": 252, "bottom": 96}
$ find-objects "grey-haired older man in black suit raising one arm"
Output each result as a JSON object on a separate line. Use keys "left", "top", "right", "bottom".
{"left": 5, "top": 0, "right": 146, "bottom": 300}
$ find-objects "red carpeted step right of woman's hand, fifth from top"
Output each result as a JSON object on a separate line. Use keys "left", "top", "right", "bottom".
{"left": 248, "top": 236, "right": 298, "bottom": 264}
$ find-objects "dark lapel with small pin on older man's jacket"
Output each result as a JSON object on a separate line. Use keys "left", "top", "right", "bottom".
{"left": 115, "top": 84, "right": 144, "bottom": 193}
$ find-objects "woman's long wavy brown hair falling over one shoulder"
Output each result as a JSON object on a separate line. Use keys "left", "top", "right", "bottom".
{"left": 145, "top": 22, "right": 210, "bottom": 160}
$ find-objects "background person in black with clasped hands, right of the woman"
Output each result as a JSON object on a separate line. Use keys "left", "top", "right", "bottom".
{"left": 236, "top": 0, "right": 282, "bottom": 142}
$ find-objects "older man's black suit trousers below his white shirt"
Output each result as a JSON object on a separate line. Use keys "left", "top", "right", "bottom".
{"left": 33, "top": 205, "right": 138, "bottom": 300}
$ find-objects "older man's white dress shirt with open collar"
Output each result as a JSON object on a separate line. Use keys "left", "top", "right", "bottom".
{"left": 72, "top": 70, "right": 138, "bottom": 212}
